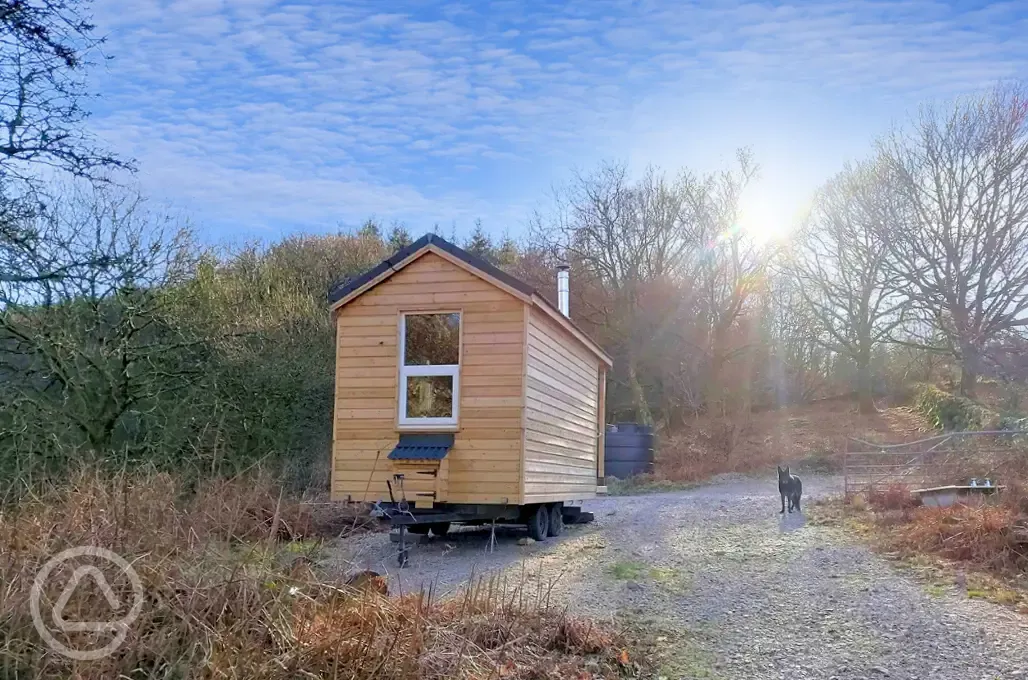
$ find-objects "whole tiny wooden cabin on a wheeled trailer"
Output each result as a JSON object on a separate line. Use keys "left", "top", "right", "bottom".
{"left": 332, "top": 235, "right": 612, "bottom": 538}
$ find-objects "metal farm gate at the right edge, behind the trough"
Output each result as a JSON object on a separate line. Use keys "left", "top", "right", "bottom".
{"left": 843, "top": 430, "right": 1028, "bottom": 494}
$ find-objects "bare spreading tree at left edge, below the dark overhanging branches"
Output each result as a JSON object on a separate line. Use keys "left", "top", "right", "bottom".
{"left": 0, "top": 189, "right": 201, "bottom": 453}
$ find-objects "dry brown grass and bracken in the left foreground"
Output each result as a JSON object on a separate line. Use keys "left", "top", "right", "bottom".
{"left": 0, "top": 472, "right": 635, "bottom": 680}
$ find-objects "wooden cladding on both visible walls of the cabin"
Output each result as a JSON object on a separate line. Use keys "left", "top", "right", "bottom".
{"left": 332, "top": 246, "right": 602, "bottom": 506}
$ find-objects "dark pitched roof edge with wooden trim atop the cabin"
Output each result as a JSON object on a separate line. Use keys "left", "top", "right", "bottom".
{"left": 329, "top": 234, "right": 614, "bottom": 366}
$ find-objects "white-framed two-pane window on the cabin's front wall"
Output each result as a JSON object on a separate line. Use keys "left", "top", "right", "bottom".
{"left": 398, "top": 312, "right": 461, "bottom": 428}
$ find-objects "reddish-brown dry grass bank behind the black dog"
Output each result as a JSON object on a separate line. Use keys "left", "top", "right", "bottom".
{"left": 654, "top": 400, "right": 930, "bottom": 482}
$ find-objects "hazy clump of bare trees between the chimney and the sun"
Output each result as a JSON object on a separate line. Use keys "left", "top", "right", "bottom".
{"left": 534, "top": 152, "right": 763, "bottom": 422}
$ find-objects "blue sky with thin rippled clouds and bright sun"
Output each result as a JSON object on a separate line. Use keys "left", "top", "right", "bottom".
{"left": 89, "top": 0, "right": 1028, "bottom": 242}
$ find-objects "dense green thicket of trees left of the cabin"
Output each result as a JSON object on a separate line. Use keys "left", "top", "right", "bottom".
{"left": 0, "top": 197, "right": 388, "bottom": 497}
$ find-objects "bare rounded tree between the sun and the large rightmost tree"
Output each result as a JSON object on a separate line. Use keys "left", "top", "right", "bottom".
{"left": 786, "top": 163, "right": 908, "bottom": 414}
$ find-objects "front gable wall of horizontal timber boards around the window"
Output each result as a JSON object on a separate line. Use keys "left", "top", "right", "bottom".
{"left": 332, "top": 253, "right": 524, "bottom": 503}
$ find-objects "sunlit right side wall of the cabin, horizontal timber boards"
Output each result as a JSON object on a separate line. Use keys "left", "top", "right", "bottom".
{"left": 523, "top": 304, "right": 599, "bottom": 503}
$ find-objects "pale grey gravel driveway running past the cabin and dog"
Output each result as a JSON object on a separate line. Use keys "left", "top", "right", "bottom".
{"left": 331, "top": 471, "right": 1028, "bottom": 680}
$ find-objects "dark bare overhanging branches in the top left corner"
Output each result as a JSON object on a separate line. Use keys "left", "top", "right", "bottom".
{"left": 0, "top": 0, "right": 131, "bottom": 296}
